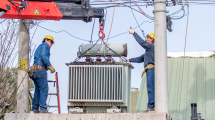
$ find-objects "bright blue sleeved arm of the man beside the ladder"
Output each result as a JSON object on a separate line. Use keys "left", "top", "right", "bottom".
{"left": 41, "top": 44, "right": 51, "bottom": 66}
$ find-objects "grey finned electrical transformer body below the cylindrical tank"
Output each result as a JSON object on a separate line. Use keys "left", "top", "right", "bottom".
{"left": 66, "top": 43, "right": 133, "bottom": 113}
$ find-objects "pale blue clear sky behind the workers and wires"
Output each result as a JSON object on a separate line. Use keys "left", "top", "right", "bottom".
{"left": 22, "top": 2, "right": 215, "bottom": 113}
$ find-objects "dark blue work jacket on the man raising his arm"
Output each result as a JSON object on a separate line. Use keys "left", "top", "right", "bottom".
{"left": 130, "top": 33, "right": 155, "bottom": 67}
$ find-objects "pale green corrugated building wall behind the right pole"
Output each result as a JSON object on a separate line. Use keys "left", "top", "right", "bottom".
{"left": 135, "top": 57, "right": 215, "bottom": 120}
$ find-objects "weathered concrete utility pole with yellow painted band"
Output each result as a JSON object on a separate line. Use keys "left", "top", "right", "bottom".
{"left": 17, "top": 20, "right": 29, "bottom": 113}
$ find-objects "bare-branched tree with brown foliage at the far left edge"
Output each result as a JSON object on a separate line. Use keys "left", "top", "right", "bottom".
{"left": 0, "top": 19, "right": 34, "bottom": 120}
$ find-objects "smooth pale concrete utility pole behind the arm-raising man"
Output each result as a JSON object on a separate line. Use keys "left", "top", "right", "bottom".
{"left": 154, "top": 0, "right": 169, "bottom": 113}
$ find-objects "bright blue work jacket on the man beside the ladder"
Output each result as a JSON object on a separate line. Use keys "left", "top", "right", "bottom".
{"left": 33, "top": 43, "right": 51, "bottom": 70}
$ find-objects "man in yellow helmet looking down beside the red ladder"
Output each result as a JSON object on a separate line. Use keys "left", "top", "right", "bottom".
{"left": 30, "top": 35, "right": 55, "bottom": 113}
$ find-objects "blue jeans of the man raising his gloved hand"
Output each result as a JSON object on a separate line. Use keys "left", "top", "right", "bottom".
{"left": 146, "top": 69, "right": 155, "bottom": 108}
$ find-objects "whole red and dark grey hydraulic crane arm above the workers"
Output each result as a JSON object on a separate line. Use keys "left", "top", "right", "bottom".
{"left": 0, "top": 0, "right": 104, "bottom": 22}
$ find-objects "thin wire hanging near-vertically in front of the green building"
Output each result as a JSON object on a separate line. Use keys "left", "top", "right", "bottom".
{"left": 178, "top": 1, "right": 189, "bottom": 120}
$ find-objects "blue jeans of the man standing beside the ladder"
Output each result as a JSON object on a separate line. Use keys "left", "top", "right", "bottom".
{"left": 32, "top": 69, "right": 48, "bottom": 111}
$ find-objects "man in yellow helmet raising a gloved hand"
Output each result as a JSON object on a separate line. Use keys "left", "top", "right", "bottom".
{"left": 128, "top": 28, "right": 155, "bottom": 113}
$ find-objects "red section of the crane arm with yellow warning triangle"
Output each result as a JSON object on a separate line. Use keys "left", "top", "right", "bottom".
{"left": 0, "top": 0, "right": 63, "bottom": 20}
